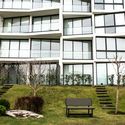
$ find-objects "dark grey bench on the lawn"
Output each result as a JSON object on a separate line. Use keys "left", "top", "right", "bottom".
{"left": 65, "top": 98, "right": 95, "bottom": 117}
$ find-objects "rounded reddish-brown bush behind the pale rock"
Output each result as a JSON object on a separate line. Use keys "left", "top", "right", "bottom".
{"left": 14, "top": 96, "right": 44, "bottom": 113}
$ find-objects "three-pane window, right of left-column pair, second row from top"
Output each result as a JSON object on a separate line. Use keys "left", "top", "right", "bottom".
{"left": 33, "top": 15, "right": 59, "bottom": 32}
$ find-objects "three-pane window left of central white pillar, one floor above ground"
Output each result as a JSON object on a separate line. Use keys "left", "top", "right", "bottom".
{"left": 31, "top": 39, "right": 60, "bottom": 58}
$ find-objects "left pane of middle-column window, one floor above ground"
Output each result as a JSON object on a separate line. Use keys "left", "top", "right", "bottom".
{"left": 64, "top": 41, "right": 72, "bottom": 59}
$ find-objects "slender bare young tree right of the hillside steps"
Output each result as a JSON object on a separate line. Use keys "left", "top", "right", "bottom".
{"left": 111, "top": 56, "right": 125, "bottom": 114}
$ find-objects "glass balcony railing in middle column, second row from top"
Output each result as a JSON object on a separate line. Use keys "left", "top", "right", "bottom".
{"left": 64, "top": 26, "right": 92, "bottom": 35}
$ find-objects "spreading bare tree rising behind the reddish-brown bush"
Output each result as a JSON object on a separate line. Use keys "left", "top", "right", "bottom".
{"left": 19, "top": 61, "right": 47, "bottom": 96}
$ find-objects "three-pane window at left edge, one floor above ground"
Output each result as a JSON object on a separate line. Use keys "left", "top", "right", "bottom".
{"left": 0, "top": 40, "right": 29, "bottom": 58}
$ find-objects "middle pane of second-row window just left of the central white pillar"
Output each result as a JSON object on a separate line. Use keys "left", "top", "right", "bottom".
{"left": 42, "top": 17, "right": 50, "bottom": 31}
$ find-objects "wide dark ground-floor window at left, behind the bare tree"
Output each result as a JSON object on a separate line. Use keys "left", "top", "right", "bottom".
{"left": 0, "top": 63, "right": 59, "bottom": 85}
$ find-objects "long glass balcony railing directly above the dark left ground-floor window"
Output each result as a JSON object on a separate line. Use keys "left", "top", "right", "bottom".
{"left": 0, "top": 49, "right": 60, "bottom": 58}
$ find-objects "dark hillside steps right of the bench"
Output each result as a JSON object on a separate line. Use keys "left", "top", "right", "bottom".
{"left": 96, "top": 86, "right": 115, "bottom": 110}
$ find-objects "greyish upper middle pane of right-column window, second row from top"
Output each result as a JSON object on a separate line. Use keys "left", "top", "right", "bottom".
{"left": 105, "top": 14, "right": 114, "bottom": 26}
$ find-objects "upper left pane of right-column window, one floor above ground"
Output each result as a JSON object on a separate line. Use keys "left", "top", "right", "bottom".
{"left": 96, "top": 38, "right": 106, "bottom": 50}
